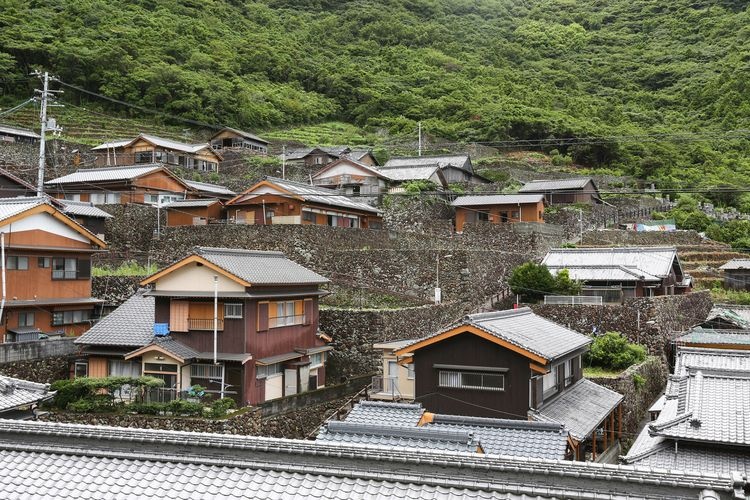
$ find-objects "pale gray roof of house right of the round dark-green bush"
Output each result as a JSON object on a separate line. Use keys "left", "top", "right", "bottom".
{"left": 542, "top": 247, "right": 679, "bottom": 280}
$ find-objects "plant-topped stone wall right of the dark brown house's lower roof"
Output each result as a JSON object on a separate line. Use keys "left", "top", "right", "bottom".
{"left": 590, "top": 357, "right": 669, "bottom": 455}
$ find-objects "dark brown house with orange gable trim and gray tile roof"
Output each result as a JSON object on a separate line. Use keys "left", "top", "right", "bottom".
{"left": 395, "top": 308, "right": 622, "bottom": 460}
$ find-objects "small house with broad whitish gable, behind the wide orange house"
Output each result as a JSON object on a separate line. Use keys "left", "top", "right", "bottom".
{"left": 312, "top": 157, "right": 390, "bottom": 197}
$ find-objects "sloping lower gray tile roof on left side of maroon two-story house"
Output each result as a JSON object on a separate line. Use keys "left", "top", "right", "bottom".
{"left": 74, "top": 290, "right": 154, "bottom": 347}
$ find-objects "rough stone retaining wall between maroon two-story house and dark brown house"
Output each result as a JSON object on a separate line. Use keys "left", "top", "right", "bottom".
{"left": 320, "top": 304, "right": 466, "bottom": 382}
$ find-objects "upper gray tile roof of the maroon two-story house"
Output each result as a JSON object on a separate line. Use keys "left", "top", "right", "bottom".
{"left": 194, "top": 247, "right": 329, "bottom": 285}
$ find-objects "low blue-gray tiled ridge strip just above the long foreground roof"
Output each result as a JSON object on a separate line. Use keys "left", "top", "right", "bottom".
{"left": 316, "top": 421, "right": 479, "bottom": 453}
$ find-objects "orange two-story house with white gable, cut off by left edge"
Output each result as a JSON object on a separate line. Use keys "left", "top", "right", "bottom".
{"left": 0, "top": 198, "right": 106, "bottom": 342}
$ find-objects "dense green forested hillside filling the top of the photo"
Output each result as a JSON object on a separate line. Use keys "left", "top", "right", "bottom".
{"left": 0, "top": 0, "right": 750, "bottom": 204}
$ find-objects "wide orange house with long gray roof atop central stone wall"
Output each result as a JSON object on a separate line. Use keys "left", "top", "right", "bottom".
{"left": 226, "top": 177, "right": 382, "bottom": 229}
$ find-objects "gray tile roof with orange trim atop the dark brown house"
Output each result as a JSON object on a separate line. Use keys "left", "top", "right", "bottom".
{"left": 403, "top": 307, "right": 591, "bottom": 361}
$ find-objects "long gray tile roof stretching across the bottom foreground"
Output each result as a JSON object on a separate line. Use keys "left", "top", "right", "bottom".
{"left": 0, "top": 420, "right": 747, "bottom": 500}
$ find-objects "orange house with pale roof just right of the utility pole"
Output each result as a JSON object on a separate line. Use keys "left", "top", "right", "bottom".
{"left": 45, "top": 163, "right": 226, "bottom": 205}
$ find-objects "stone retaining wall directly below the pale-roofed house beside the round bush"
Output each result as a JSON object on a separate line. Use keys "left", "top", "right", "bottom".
{"left": 530, "top": 290, "right": 713, "bottom": 356}
